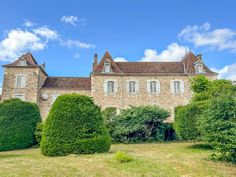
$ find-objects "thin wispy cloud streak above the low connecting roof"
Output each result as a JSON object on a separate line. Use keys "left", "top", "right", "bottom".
{"left": 61, "top": 39, "right": 96, "bottom": 49}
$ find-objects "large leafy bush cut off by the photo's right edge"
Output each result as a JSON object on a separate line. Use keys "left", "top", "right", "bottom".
{"left": 199, "top": 95, "right": 236, "bottom": 162}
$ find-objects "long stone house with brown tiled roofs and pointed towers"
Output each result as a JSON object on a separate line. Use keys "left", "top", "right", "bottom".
{"left": 2, "top": 51, "right": 217, "bottom": 121}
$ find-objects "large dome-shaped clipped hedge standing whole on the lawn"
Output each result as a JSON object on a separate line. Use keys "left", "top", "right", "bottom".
{"left": 40, "top": 94, "right": 111, "bottom": 156}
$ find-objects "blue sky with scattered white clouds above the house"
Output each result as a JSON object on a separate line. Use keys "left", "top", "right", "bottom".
{"left": 0, "top": 0, "right": 236, "bottom": 82}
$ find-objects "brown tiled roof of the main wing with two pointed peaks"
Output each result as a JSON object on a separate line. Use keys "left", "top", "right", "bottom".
{"left": 93, "top": 52, "right": 217, "bottom": 75}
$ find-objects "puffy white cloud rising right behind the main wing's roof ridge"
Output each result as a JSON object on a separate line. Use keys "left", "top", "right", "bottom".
{"left": 140, "top": 43, "right": 189, "bottom": 62}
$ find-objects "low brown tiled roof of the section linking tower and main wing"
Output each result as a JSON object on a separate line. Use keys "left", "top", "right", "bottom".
{"left": 43, "top": 77, "right": 91, "bottom": 90}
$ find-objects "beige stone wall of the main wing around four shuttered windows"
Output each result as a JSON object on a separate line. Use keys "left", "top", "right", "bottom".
{"left": 91, "top": 75, "right": 217, "bottom": 121}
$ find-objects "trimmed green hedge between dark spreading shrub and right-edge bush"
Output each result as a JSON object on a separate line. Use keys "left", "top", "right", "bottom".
{"left": 174, "top": 101, "right": 209, "bottom": 140}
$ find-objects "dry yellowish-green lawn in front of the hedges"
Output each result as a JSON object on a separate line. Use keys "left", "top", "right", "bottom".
{"left": 0, "top": 143, "right": 236, "bottom": 177}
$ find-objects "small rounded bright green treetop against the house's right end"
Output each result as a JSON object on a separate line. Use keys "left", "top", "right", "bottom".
{"left": 191, "top": 75, "right": 210, "bottom": 93}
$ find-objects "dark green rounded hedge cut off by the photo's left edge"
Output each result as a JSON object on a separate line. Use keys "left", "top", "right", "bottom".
{"left": 0, "top": 99, "right": 41, "bottom": 151}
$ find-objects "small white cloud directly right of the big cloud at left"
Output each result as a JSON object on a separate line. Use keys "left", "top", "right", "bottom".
{"left": 33, "top": 26, "right": 59, "bottom": 39}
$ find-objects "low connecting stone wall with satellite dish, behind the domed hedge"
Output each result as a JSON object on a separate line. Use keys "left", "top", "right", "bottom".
{"left": 39, "top": 88, "right": 90, "bottom": 120}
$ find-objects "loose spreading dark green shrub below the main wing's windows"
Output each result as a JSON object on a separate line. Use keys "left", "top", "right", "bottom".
{"left": 110, "top": 106, "right": 170, "bottom": 143}
